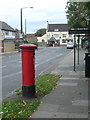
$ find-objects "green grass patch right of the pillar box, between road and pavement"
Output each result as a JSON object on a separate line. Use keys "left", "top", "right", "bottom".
{"left": 36, "top": 74, "right": 60, "bottom": 95}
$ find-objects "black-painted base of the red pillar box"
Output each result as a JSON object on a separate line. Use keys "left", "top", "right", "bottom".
{"left": 22, "top": 85, "right": 36, "bottom": 98}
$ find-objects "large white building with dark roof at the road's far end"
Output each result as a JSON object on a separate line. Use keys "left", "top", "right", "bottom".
{"left": 38, "top": 24, "right": 74, "bottom": 45}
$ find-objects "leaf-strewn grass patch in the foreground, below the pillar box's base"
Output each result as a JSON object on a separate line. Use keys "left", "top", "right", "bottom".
{"left": 2, "top": 100, "right": 40, "bottom": 119}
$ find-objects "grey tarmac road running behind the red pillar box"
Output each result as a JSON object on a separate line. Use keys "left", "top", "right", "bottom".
{"left": 0, "top": 46, "right": 72, "bottom": 98}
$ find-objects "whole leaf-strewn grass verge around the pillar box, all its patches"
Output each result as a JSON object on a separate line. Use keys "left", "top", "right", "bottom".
{"left": 2, "top": 74, "right": 60, "bottom": 119}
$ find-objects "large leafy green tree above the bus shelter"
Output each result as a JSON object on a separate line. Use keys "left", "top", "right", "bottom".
{"left": 66, "top": 2, "right": 90, "bottom": 28}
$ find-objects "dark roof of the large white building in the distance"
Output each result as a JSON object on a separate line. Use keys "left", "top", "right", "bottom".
{"left": 48, "top": 24, "right": 69, "bottom": 32}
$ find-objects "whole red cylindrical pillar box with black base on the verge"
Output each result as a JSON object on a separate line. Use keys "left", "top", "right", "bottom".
{"left": 19, "top": 44, "right": 36, "bottom": 98}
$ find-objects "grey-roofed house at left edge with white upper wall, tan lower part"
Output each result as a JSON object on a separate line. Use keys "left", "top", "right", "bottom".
{"left": 0, "top": 21, "right": 16, "bottom": 52}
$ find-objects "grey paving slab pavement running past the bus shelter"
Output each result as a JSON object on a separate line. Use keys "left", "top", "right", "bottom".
{"left": 30, "top": 51, "right": 90, "bottom": 118}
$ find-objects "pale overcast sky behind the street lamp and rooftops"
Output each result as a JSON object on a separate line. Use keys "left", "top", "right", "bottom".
{"left": 0, "top": 0, "right": 68, "bottom": 33}
